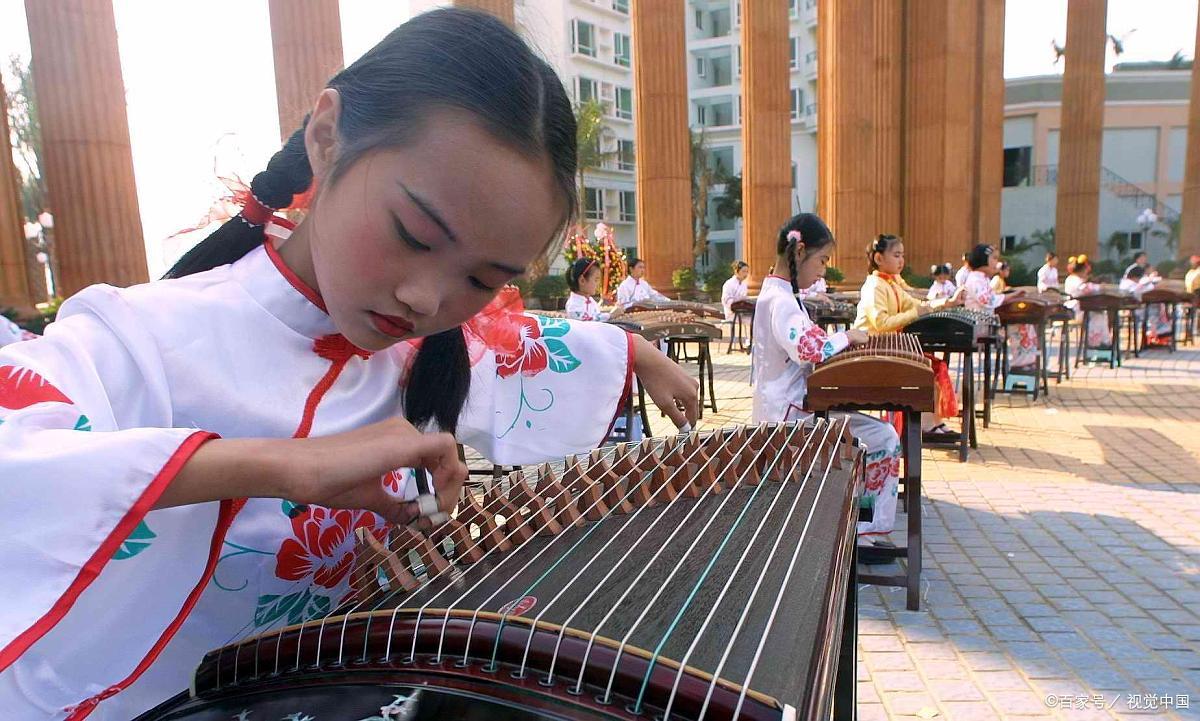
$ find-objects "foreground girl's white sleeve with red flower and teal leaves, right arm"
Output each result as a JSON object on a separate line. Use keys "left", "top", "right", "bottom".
{"left": 458, "top": 316, "right": 634, "bottom": 464}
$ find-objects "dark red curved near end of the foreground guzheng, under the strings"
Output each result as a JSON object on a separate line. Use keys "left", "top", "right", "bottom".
{"left": 194, "top": 609, "right": 777, "bottom": 721}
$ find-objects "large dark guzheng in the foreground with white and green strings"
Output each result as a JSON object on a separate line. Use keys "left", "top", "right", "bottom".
{"left": 142, "top": 420, "right": 863, "bottom": 721}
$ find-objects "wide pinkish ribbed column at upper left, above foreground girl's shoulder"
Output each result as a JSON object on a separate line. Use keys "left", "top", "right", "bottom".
{"left": 25, "top": 0, "right": 148, "bottom": 296}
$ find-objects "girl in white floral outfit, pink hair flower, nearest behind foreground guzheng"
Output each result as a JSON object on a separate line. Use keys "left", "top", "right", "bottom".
{"left": 751, "top": 212, "right": 900, "bottom": 536}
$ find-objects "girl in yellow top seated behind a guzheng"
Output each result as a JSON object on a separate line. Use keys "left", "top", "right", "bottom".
{"left": 854, "top": 235, "right": 962, "bottom": 433}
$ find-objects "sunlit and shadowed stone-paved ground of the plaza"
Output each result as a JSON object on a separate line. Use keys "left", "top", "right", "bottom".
{"left": 652, "top": 333, "right": 1200, "bottom": 721}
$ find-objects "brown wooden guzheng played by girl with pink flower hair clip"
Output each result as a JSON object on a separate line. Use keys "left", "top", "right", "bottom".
{"left": 804, "top": 334, "right": 934, "bottom": 413}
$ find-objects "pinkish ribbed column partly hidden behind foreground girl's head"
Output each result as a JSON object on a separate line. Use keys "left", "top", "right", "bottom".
{"left": 268, "top": 0, "right": 344, "bottom": 140}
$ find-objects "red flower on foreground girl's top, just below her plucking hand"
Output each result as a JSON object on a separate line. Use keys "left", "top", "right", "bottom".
{"left": 275, "top": 506, "right": 383, "bottom": 588}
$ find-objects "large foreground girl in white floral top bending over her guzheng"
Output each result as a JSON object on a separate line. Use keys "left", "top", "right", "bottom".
{"left": 0, "top": 10, "right": 697, "bottom": 720}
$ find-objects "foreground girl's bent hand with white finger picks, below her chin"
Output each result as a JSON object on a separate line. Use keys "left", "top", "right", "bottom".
{"left": 286, "top": 416, "right": 467, "bottom": 524}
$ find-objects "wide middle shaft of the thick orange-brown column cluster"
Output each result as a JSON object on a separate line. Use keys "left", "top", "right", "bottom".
{"left": 902, "top": 0, "right": 991, "bottom": 271}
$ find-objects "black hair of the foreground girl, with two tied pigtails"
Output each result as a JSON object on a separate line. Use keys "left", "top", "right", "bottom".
{"left": 166, "top": 8, "right": 578, "bottom": 433}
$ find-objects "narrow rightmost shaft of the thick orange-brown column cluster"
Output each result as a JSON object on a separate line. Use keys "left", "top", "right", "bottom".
{"left": 969, "top": 0, "right": 1004, "bottom": 250}
